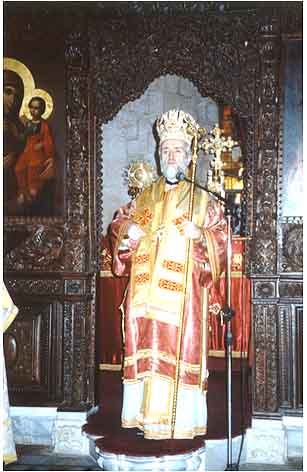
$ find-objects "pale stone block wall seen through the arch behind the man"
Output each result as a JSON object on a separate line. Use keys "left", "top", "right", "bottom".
{"left": 102, "top": 75, "right": 218, "bottom": 233}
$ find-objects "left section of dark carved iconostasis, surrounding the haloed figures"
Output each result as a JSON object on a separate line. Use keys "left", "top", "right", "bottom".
{"left": 4, "top": 2, "right": 95, "bottom": 410}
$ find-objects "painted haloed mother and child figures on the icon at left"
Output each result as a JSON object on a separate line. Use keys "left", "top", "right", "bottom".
{"left": 3, "top": 58, "right": 56, "bottom": 216}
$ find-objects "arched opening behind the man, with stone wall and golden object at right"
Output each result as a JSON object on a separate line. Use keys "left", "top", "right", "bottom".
{"left": 99, "top": 74, "right": 246, "bottom": 236}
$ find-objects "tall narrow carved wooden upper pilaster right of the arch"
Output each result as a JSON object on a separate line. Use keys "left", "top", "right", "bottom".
{"left": 252, "top": 30, "right": 279, "bottom": 274}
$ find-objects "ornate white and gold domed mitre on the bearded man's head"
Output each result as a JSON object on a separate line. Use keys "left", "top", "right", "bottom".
{"left": 156, "top": 110, "right": 199, "bottom": 145}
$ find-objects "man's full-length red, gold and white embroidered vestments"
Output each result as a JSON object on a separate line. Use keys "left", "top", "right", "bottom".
{"left": 111, "top": 177, "right": 226, "bottom": 439}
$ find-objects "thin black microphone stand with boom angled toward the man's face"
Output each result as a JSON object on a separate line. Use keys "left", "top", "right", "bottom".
{"left": 176, "top": 172, "right": 239, "bottom": 470}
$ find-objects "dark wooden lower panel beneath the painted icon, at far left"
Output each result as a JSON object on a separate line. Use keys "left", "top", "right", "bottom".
{"left": 4, "top": 303, "right": 61, "bottom": 404}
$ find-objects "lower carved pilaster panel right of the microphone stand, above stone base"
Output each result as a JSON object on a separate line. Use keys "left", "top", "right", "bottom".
{"left": 253, "top": 304, "right": 278, "bottom": 414}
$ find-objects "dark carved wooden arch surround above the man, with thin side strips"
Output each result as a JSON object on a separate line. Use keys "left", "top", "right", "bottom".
{"left": 90, "top": 15, "right": 260, "bottom": 254}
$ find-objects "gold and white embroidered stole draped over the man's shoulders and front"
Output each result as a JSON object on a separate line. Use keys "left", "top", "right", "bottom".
{"left": 131, "top": 178, "right": 208, "bottom": 326}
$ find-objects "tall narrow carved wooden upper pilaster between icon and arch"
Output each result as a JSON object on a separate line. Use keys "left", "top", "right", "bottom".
{"left": 64, "top": 29, "right": 90, "bottom": 272}
